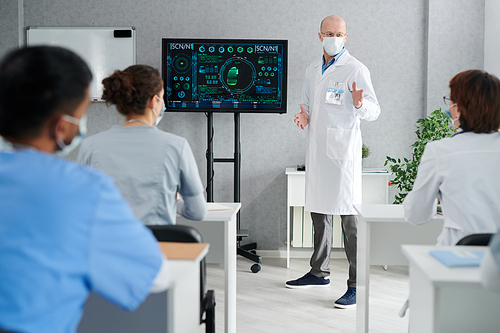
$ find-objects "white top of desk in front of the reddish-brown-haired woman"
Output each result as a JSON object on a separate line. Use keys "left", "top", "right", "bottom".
{"left": 354, "top": 204, "right": 443, "bottom": 222}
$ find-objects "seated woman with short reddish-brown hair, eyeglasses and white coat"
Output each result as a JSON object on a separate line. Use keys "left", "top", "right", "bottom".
{"left": 403, "top": 70, "right": 500, "bottom": 245}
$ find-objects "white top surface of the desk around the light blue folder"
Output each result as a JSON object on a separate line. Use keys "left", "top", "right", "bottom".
{"left": 401, "top": 245, "right": 486, "bottom": 285}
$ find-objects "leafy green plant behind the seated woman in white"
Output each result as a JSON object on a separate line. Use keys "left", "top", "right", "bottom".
{"left": 384, "top": 109, "right": 456, "bottom": 204}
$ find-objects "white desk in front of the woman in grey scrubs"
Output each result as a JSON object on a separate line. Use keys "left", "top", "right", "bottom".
{"left": 177, "top": 202, "right": 241, "bottom": 333}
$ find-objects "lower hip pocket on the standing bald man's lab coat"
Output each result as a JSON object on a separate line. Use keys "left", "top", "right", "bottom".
{"left": 326, "top": 128, "right": 356, "bottom": 161}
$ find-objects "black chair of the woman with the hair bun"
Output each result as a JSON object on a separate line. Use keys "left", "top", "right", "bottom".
{"left": 147, "top": 225, "right": 215, "bottom": 333}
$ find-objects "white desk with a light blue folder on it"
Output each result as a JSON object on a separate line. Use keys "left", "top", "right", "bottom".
{"left": 402, "top": 245, "right": 500, "bottom": 333}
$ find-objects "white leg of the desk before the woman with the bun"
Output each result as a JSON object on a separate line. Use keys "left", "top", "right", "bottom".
{"left": 224, "top": 214, "right": 237, "bottom": 333}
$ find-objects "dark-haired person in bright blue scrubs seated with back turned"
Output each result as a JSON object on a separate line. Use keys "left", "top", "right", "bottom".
{"left": 0, "top": 46, "right": 169, "bottom": 333}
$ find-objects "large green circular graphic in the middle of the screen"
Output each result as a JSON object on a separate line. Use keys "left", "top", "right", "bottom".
{"left": 219, "top": 57, "right": 256, "bottom": 94}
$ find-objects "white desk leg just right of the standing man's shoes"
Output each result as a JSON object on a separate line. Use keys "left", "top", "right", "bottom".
{"left": 356, "top": 215, "right": 370, "bottom": 333}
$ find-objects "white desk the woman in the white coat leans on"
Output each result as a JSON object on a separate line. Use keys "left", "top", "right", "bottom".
{"left": 354, "top": 204, "right": 443, "bottom": 333}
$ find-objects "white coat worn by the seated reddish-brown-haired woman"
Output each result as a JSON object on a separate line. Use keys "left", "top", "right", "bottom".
{"left": 403, "top": 132, "right": 500, "bottom": 245}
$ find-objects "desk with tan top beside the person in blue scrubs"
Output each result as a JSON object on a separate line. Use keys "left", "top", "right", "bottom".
{"left": 78, "top": 243, "right": 209, "bottom": 333}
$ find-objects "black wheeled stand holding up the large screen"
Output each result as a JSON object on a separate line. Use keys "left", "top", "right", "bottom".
{"left": 206, "top": 111, "right": 262, "bottom": 273}
